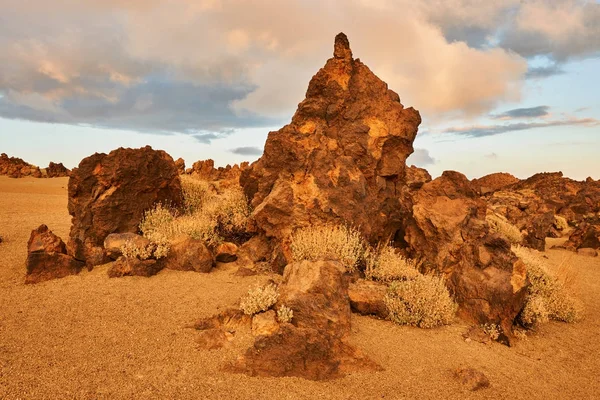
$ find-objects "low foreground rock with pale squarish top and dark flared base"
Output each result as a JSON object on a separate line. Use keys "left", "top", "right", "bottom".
{"left": 231, "top": 261, "right": 380, "bottom": 380}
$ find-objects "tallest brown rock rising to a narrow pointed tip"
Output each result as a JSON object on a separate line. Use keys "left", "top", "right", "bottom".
{"left": 240, "top": 34, "right": 421, "bottom": 242}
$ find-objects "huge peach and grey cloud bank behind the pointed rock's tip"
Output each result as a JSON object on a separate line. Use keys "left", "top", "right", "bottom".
{"left": 0, "top": 0, "right": 527, "bottom": 140}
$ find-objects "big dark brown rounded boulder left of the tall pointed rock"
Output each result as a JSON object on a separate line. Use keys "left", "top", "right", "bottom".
{"left": 67, "top": 146, "right": 183, "bottom": 267}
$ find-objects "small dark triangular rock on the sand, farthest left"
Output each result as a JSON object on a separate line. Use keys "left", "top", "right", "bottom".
{"left": 25, "top": 225, "right": 83, "bottom": 283}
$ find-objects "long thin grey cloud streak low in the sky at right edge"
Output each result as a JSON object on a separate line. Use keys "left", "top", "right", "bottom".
{"left": 442, "top": 118, "right": 600, "bottom": 138}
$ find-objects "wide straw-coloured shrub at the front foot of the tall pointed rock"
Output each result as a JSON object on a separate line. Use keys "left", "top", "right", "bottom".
{"left": 290, "top": 225, "right": 365, "bottom": 272}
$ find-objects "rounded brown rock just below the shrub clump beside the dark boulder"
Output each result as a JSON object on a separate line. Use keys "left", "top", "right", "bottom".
{"left": 165, "top": 237, "right": 215, "bottom": 272}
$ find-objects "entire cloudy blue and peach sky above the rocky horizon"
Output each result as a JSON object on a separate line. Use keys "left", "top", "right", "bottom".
{"left": 0, "top": 0, "right": 600, "bottom": 179}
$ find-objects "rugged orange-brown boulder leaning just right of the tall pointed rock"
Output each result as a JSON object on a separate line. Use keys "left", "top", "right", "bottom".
{"left": 396, "top": 171, "right": 528, "bottom": 340}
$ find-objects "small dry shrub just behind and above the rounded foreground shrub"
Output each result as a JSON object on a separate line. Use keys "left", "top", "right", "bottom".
{"left": 365, "top": 246, "right": 419, "bottom": 282}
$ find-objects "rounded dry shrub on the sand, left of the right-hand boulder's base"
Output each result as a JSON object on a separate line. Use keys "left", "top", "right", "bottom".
{"left": 384, "top": 275, "right": 457, "bottom": 328}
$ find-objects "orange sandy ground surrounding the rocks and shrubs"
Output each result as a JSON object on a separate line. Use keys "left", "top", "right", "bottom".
{"left": 0, "top": 177, "right": 600, "bottom": 399}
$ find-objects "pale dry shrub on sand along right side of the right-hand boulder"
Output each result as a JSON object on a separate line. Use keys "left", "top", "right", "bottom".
{"left": 512, "top": 246, "right": 582, "bottom": 326}
